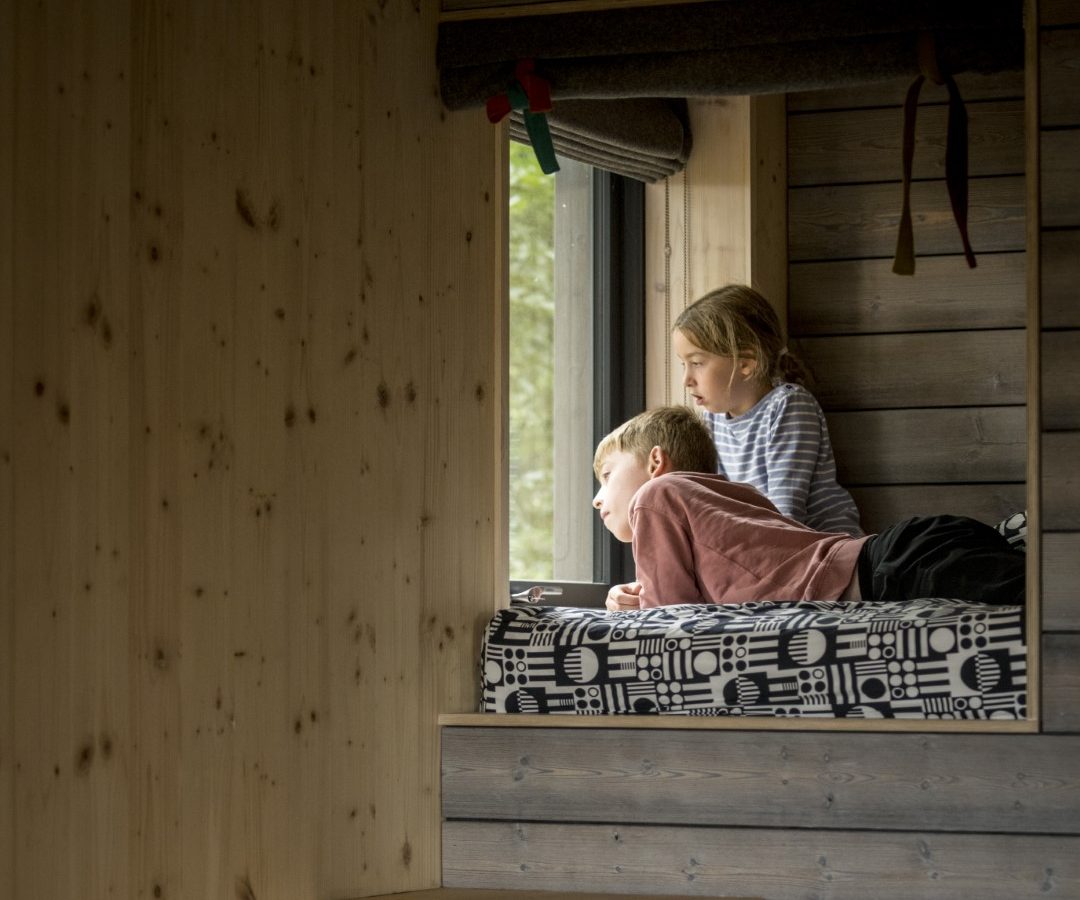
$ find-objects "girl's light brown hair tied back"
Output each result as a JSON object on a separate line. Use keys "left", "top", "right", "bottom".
{"left": 672, "top": 284, "right": 809, "bottom": 385}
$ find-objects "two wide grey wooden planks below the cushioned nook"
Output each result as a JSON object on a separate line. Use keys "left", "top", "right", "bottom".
{"left": 443, "top": 728, "right": 1080, "bottom": 900}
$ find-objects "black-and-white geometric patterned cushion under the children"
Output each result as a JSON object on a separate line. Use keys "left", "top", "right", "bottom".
{"left": 481, "top": 600, "right": 1027, "bottom": 718}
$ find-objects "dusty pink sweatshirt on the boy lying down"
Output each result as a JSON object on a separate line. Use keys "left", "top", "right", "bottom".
{"left": 630, "top": 472, "right": 866, "bottom": 608}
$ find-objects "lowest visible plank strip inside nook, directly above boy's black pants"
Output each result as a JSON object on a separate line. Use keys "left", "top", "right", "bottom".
{"left": 851, "top": 483, "right": 1027, "bottom": 533}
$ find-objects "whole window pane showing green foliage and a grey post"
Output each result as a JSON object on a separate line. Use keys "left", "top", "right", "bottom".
{"left": 510, "top": 144, "right": 593, "bottom": 581}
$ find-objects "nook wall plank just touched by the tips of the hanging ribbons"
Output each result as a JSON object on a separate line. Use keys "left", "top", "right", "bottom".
{"left": 788, "top": 252, "right": 1019, "bottom": 336}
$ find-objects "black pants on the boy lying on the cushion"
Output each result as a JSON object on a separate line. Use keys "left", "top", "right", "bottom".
{"left": 859, "top": 515, "right": 1027, "bottom": 606}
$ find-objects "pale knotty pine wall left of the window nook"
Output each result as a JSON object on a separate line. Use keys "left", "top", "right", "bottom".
{"left": 0, "top": 0, "right": 507, "bottom": 900}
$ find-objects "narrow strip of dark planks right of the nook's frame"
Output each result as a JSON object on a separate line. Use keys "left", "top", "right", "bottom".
{"left": 1037, "top": 0, "right": 1080, "bottom": 733}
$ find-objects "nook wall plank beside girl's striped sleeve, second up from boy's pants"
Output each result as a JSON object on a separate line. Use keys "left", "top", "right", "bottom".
{"left": 828, "top": 406, "right": 1027, "bottom": 485}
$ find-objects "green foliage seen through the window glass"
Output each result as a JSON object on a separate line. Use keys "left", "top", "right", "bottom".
{"left": 510, "top": 143, "right": 555, "bottom": 580}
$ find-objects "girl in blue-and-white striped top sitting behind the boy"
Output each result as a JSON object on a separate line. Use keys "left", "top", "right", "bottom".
{"left": 672, "top": 284, "right": 863, "bottom": 536}
